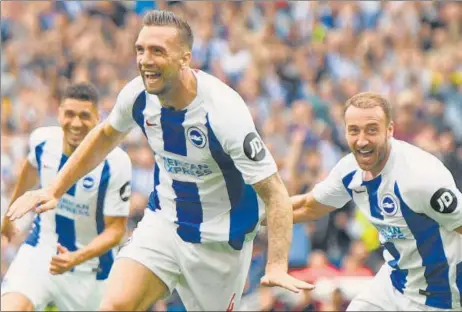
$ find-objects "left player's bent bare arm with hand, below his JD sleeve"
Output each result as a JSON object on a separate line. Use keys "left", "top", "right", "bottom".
{"left": 50, "top": 216, "right": 127, "bottom": 275}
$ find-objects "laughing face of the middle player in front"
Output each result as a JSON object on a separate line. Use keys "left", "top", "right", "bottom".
{"left": 135, "top": 26, "right": 183, "bottom": 95}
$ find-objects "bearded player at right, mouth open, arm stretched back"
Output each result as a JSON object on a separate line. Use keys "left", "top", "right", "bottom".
{"left": 292, "top": 93, "right": 462, "bottom": 311}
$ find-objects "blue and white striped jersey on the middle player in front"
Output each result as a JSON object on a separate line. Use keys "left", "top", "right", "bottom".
{"left": 109, "top": 71, "right": 277, "bottom": 250}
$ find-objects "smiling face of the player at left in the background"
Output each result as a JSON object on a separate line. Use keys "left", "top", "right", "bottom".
{"left": 58, "top": 99, "right": 98, "bottom": 149}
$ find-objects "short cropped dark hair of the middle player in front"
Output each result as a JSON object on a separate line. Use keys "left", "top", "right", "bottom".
{"left": 143, "top": 10, "right": 194, "bottom": 50}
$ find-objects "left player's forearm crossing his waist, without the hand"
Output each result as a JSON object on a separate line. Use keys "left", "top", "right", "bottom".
{"left": 75, "top": 227, "right": 125, "bottom": 265}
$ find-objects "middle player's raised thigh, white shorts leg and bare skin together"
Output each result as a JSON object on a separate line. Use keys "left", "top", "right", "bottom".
{"left": 102, "top": 210, "right": 180, "bottom": 310}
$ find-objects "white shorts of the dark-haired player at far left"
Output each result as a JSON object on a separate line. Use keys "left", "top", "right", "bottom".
{"left": 1, "top": 244, "right": 106, "bottom": 311}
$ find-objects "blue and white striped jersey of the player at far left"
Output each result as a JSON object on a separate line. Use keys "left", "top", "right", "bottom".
{"left": 25, "top": 127, "right": 131, "bottom": 280}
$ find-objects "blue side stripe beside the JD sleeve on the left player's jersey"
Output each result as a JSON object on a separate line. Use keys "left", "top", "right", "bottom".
{"left": 96, "top": 160, "right": 114, "bottom": 280}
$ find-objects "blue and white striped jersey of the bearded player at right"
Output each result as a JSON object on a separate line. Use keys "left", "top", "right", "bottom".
{"left": 313, "top": 140, "right": 462, "bottom": 309}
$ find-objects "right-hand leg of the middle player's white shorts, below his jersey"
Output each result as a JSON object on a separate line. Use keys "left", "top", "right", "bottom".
{"left": 177, "top": 242, "right": 253, "bottom": 311}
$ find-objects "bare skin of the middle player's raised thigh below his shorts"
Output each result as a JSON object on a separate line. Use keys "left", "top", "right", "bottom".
{"left": 100, "top": 258, "right": 169, "bottom": 311}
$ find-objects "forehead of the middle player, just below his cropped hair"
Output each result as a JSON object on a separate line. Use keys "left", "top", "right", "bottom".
{"left": 135, "top": 26, "right": 179, "bottom": 47}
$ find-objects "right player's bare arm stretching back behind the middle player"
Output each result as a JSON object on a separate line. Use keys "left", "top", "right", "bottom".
{"left": 290, "top": 193, "right": 335, "bottom": 223}
